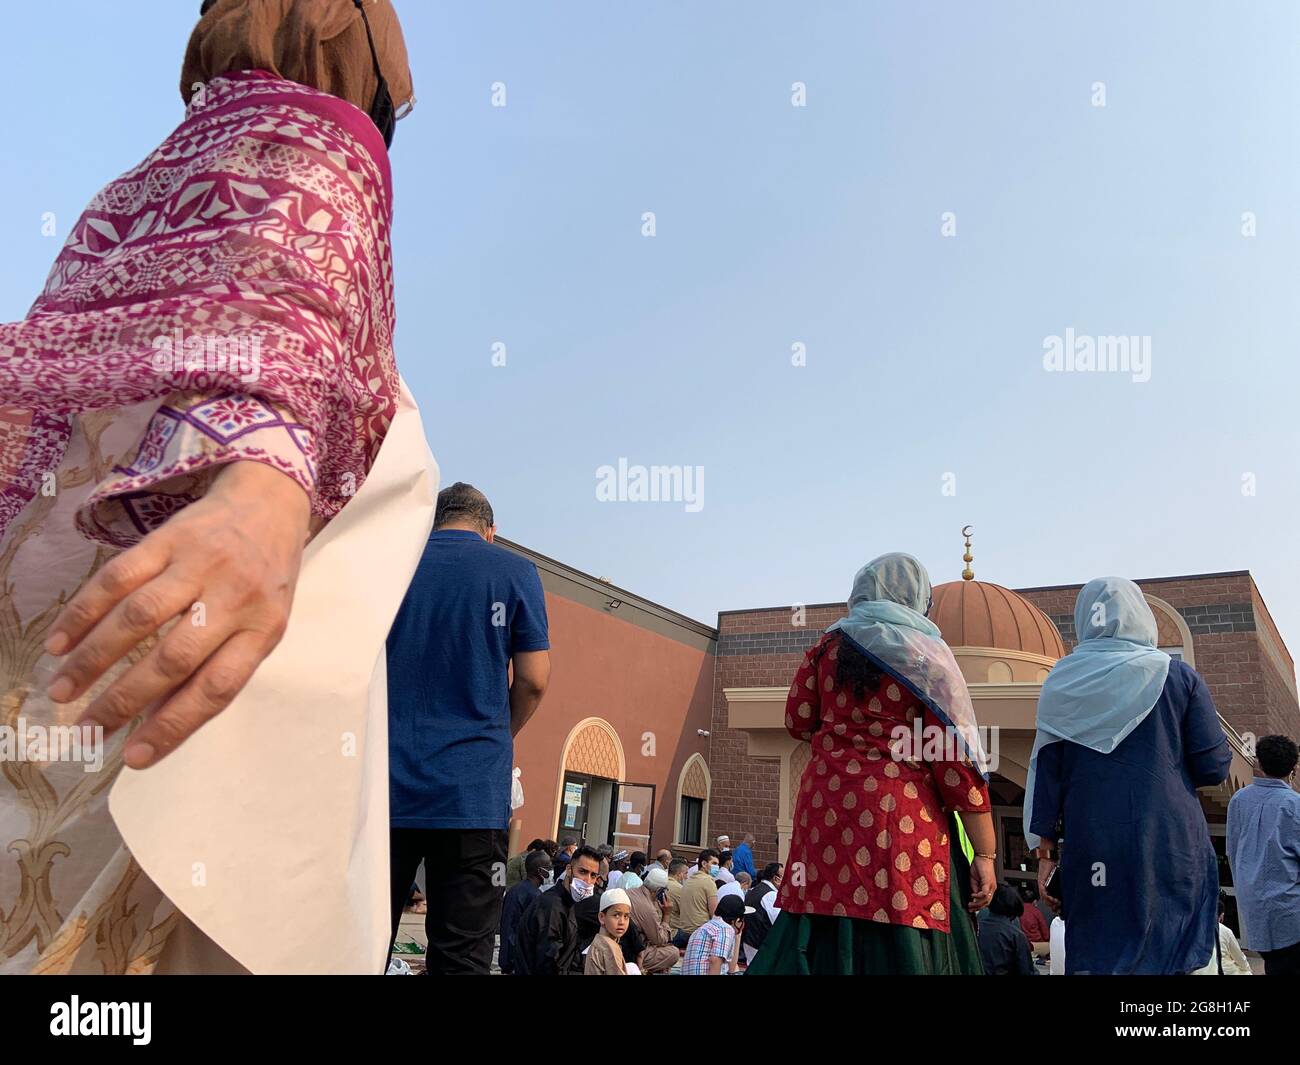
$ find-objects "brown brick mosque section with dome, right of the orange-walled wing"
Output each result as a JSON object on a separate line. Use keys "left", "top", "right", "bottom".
{"left": 710, "top": 541, "right": 1300, "bottom": 910}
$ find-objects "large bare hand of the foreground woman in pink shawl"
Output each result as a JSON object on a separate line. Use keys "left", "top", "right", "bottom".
{"left": 46, "top": 462, "right": 311, "bottom": 769}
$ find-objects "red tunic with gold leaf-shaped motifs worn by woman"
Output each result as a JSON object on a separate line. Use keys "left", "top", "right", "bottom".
{"left": 779, "top": 631, "right": 989, "bottom": 932}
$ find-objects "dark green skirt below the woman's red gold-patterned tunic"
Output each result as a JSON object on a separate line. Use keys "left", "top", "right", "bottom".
{"left": 745, "top": 831, "right": 984, "bottom": 977}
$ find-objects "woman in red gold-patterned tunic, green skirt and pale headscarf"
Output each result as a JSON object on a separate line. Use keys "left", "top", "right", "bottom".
{"left": 749, "top": 554, "right": 995, "bottom": 975}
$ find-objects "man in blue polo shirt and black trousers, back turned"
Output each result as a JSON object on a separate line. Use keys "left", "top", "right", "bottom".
{"left": 387, "top": 482, "right": 550, "bottom": 975}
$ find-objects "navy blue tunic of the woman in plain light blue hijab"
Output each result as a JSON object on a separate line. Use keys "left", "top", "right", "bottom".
{"left": 1030, "top": 659, "right": 1232, "bottom": 974}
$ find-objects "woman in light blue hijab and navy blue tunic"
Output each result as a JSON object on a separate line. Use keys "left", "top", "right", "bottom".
{"left": 1024, "top": 577, "right": 1232, "bottom": 974}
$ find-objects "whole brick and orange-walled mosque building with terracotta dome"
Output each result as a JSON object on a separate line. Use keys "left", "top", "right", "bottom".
{"left": 498, "top": 537, "right": 1300, "bottom": 915}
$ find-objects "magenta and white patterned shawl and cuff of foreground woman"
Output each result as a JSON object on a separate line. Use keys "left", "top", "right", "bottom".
{"left": 0, "top": 72, "right": 398, "bottom": 546}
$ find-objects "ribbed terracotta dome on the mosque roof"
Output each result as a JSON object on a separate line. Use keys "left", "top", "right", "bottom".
{"left": 930, "top": 580, "right": 1065, "bottom": 659}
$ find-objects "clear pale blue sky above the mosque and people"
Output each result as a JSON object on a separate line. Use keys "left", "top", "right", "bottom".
{"left": 0, "top": 0, "right": 1300, "bottom": 654}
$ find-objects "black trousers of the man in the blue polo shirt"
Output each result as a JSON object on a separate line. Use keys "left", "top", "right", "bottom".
{"left": 389, "top": 827, "right": 508, "bottom": 977}
